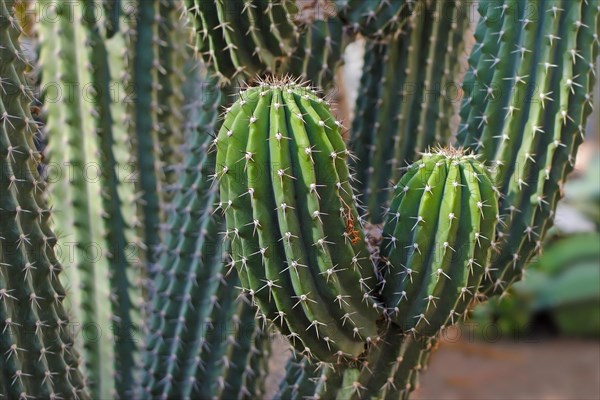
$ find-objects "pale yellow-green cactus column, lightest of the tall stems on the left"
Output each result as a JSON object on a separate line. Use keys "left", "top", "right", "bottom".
{"left": 39, "top": 1, "right": 141, "bottom": 397}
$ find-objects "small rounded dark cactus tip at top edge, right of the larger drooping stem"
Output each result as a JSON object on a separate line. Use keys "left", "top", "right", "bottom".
{"left": 335, "top": 0, "right": 416, "bottom": 38}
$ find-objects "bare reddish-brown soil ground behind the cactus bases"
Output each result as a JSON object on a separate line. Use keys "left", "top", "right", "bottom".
{"left": 267, "top": 339, "right": 600, "bottom": 400}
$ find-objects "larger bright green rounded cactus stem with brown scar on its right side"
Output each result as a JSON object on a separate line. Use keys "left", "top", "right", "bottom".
{"left": 215, "top": 81, "right": 378, "bottom": 361}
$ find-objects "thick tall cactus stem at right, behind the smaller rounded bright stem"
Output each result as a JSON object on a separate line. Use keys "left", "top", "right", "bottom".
{"left": 458, "top": 1, "right": 598, "bottom": 293}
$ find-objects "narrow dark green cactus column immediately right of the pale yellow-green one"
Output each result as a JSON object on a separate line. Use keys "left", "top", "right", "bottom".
{"left": 124, "top": 0, "right": 163, "bottom": 280}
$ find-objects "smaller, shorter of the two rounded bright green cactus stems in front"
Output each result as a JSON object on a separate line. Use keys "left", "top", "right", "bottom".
{"left": 381, "top": 149, "right": 498, "bottom": 336}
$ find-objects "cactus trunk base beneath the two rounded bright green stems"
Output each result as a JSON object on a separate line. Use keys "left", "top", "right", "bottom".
{"left": 275, "top": 324, "right": 434, "bottom": 400}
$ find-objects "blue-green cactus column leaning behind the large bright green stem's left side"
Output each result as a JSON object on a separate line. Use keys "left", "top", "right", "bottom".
{"left": 140, "top": 71, "right": 268, "bottom": 399}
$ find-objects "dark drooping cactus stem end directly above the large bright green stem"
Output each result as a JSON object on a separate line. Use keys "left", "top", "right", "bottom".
{"left": 186, "top": 0, "right": 299, "bottom": 83}
